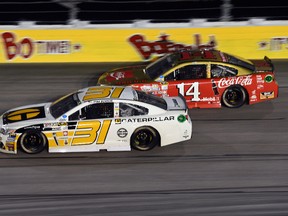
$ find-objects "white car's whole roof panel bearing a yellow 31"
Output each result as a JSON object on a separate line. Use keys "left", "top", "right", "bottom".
{"left": 77, "top": 86, "right": 138, "bottom": 102}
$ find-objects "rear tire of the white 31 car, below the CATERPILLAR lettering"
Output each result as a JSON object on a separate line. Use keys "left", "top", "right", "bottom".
{"left": 130, "top": 127, "right": 160, "bottom": 151}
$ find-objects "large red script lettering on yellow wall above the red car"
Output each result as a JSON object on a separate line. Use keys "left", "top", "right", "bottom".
{"left": 128, "top": 34, "right": 216, "bottom": 60}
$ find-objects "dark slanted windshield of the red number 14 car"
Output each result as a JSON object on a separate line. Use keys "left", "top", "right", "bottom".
{"left": 145, "top": 53, "right": 179, "bottom": 80}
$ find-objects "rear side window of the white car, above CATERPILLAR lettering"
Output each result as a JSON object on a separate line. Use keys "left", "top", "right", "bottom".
{"left": 119, "top": 103, "right": 148, "bottom": 117}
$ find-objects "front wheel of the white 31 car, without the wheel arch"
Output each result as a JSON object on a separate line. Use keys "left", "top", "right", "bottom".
{"left": 22, "top": 133, "right": 43, "bottom": 152}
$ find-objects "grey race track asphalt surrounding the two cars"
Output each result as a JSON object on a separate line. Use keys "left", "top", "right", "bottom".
{"left": 0, "top": 60, "right": 288, "bottom": 216}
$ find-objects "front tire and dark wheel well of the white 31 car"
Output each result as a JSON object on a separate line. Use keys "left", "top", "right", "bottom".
{"left": 18, "top": 130, "right": 47, "bottom": 154}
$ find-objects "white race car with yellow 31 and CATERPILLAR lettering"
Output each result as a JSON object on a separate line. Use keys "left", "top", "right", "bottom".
{"left": 0, "top": 86, "right": 192, "bottom": 154}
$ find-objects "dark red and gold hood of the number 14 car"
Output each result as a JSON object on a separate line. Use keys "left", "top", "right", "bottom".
{"left": 98, "top": 65, "right": 152, "bottom": 85}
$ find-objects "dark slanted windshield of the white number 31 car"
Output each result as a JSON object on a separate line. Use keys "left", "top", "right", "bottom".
{"left": 50, "top": 93, "right": 80, "bottom": 118}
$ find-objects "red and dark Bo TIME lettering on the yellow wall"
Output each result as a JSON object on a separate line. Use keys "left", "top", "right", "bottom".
{"left": 1, "top": 32, "right": 82, "bottom": 60}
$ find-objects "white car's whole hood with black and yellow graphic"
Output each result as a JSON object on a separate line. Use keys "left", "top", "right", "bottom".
{"left": 2, "top": 103, "right": 51, "bottom": 125}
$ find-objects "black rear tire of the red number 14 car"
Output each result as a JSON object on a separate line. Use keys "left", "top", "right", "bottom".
{"left": 222, "top": 85, "right": 247, "bottom": 108}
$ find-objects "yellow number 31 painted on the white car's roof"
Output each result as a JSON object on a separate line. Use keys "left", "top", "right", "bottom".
{"left": 83, "top": 86, "right": 124, "bottom": 101}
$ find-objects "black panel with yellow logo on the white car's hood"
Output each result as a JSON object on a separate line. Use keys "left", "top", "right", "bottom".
{"left": 7, "top": 107, "right": 45, "bottom": 123}
